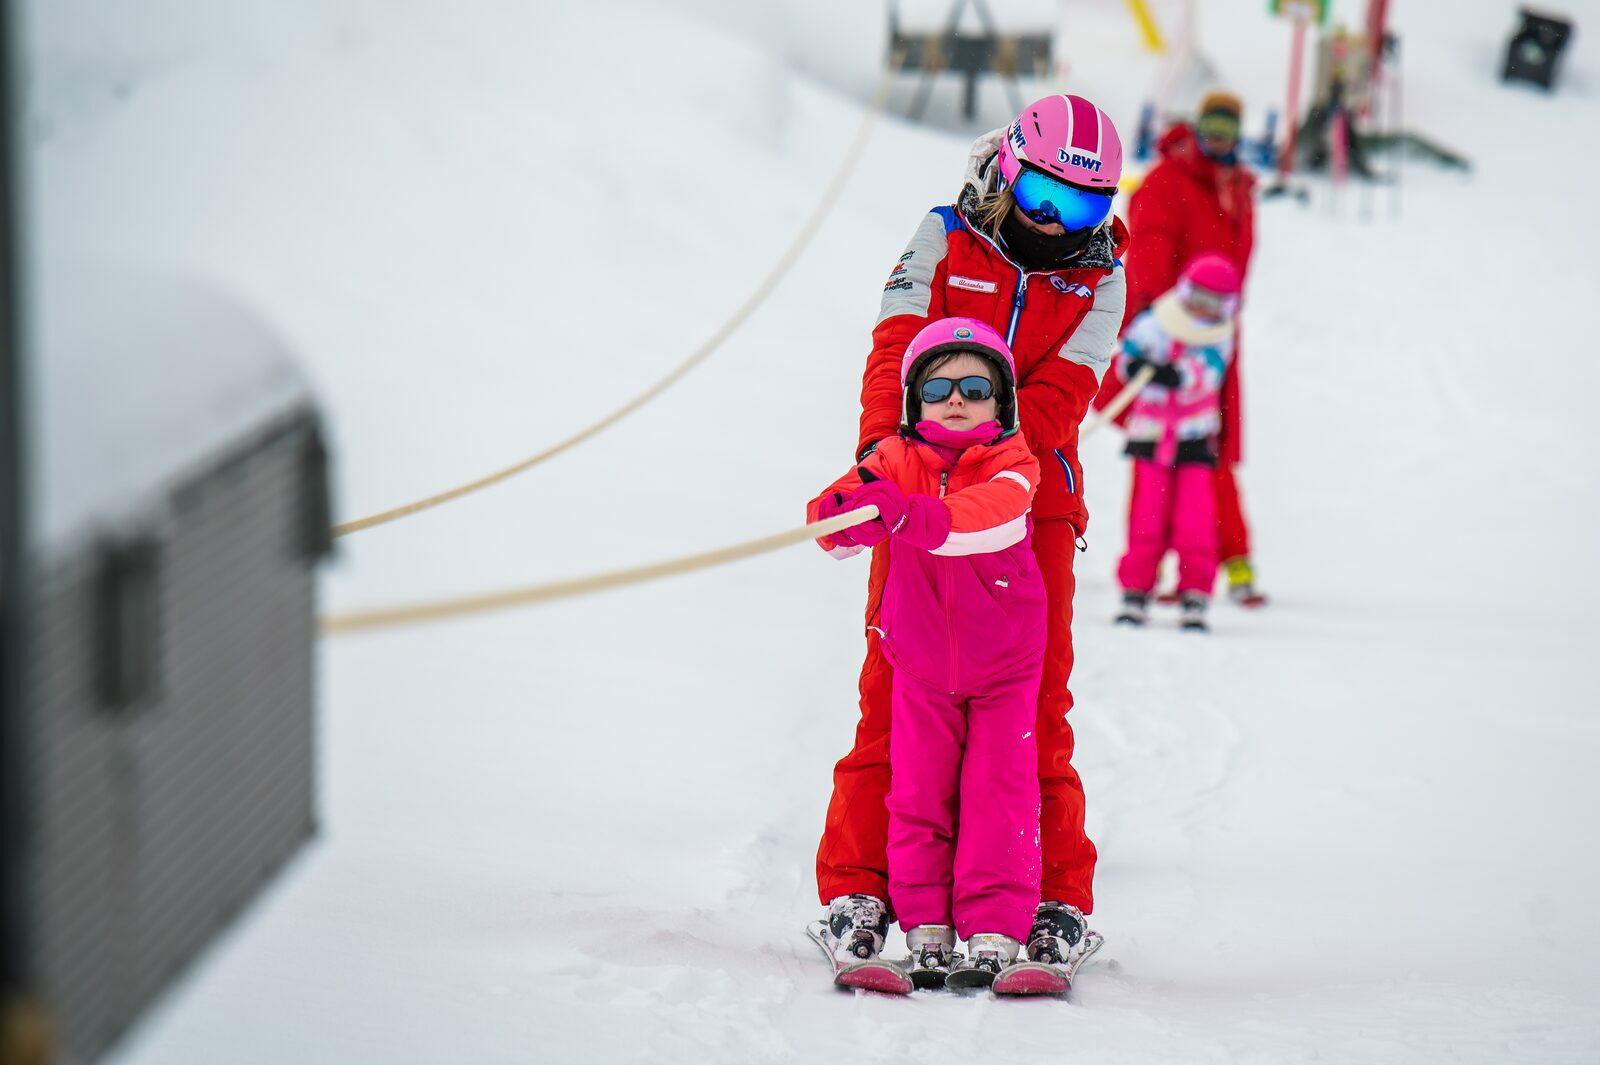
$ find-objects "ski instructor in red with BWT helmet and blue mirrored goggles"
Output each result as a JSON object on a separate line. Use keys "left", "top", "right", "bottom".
{"left": 816, "top": 96, "right": 1128, "bottom": 964}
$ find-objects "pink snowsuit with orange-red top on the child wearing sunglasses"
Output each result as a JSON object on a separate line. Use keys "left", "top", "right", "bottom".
{"left": 810, "top": 422, "right": 1045, "bottom": 940}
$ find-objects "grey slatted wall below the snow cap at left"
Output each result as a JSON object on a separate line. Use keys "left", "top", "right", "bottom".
{"left": 32, "top": 413, "right": 326, "bottom": 1065}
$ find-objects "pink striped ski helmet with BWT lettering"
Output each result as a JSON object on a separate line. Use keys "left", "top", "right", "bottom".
{"left": 1000, "top": 96, "right": 1122, "bottom": 189}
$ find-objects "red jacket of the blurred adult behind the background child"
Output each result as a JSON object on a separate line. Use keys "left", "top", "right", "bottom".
{"left": 1096, "top": 125, "right": 1256, "bottom": 464}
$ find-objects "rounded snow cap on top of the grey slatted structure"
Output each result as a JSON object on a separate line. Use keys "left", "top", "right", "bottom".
{"left": 30, "top": 262, "right": 309, "bottom": 550}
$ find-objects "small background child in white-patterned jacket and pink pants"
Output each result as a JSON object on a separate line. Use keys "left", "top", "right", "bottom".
{"left": 1117, "top": 253, "right": 1240, "bottom": 632}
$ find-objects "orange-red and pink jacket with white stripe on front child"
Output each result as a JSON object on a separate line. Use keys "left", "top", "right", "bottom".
{"left": 806, "top": 430, "right": 1045, "bottom": 694}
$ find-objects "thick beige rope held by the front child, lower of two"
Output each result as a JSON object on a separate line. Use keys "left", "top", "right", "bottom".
{"left": 322, "top": 504, "right": 878, "bottom": 635}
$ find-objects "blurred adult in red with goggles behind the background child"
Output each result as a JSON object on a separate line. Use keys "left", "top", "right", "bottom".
{"left": 1098, "top": 93, "right": 1256, "bottom": 595}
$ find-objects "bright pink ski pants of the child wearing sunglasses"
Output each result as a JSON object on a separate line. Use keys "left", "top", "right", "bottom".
{"left": 888, "top": 660, "right": 1043, "bottom": 940}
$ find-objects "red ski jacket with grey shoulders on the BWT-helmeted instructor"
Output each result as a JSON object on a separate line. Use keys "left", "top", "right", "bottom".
{"left": 856, "top": 206, "right": 1128, "bottom": 533}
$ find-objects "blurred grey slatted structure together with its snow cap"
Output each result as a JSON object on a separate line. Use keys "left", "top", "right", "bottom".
{"left": 21, "top": 267, "right": 330, "bottom": 1065}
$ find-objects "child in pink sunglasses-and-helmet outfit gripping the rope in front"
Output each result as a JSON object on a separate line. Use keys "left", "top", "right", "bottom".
{"left": 806, "top": 318, "right": 1045, "bottom": 987}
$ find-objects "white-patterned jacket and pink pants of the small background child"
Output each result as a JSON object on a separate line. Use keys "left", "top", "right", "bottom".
{"left": 1117, "top": 301, "right": 1232, "bottom": 595}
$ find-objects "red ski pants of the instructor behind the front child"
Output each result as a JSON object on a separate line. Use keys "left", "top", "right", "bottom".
{"left": 816, "top": 521, "right": 1094, "bottom": 913}
